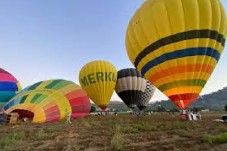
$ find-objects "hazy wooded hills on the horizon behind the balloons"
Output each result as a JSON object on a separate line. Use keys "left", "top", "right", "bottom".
{"left": 109, "top": 87, "right": 227, "bottom": 110}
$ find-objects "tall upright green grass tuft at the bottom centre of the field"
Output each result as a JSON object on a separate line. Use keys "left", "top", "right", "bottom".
{"left": 111, "top": 125, "right": 124, "bottom": 150}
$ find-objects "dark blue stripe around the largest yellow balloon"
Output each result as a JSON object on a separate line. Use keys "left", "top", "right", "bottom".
{"left": 141, "top": 47, "right": 220, "bottom": 75}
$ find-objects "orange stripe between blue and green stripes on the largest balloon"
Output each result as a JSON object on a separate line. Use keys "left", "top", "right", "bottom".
{"left": 150, "top": 64, "right": 214, "bottom": 82}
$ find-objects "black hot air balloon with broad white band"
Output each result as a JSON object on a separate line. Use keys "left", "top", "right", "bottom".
{"left": 115, "top": 68, "right": 147, "bottom": 109}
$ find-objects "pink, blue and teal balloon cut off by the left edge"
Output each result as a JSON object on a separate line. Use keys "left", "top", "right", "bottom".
{"left": 0, "top": 68, "right": 21, "bottom": 108}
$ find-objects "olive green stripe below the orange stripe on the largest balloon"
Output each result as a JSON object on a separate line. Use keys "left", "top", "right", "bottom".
{"left": 158, "top": 79, "right": 207, "bottom": 91}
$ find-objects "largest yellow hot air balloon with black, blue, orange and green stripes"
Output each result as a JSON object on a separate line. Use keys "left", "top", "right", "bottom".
{"left": 126, "top": 0, "right": 227, "bottom": 109}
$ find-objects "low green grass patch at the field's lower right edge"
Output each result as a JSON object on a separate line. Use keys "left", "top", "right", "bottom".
{"left": 202, "top": 133, "right": 227, "bottom": 144}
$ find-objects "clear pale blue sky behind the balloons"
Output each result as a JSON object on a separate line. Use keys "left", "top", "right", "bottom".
{"left": 0, "top": 0, "right": 227, "bottom": 102}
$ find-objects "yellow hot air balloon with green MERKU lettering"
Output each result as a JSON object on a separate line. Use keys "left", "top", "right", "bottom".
{"left": 79, "top": 60, "right": 117, "bottom": 110}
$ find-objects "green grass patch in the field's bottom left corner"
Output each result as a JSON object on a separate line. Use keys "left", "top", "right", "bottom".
{"left": 0, "top": 132, "right": 25, "bottom": 150}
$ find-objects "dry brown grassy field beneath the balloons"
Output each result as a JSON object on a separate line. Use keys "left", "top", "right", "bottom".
{"left": 0, "top": 113, "right": 227, "bottom": 151}
